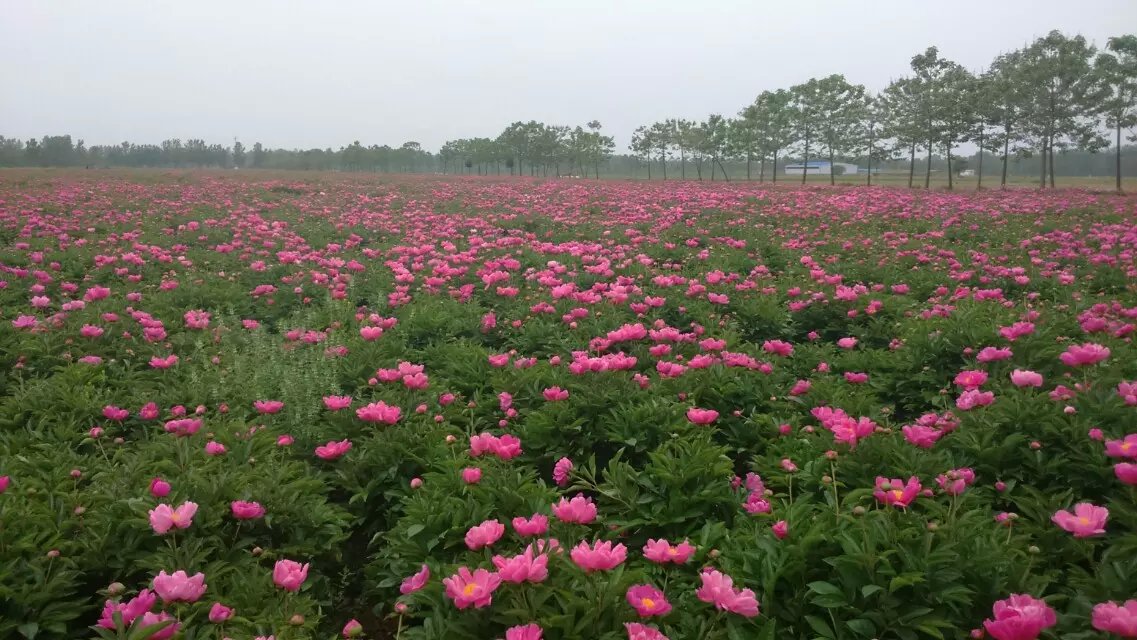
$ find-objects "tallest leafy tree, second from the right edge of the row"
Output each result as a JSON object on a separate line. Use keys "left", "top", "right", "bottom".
{"left": 1022, "top": 31, "right": 1107, "bottom": 189}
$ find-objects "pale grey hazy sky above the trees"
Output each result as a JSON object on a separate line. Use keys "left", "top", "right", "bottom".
{"left": 0, "top": 0, "right": 1137, "bottom": 152}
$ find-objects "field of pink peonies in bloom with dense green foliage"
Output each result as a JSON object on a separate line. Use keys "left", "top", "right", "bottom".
{"left": 0, "top": 174, "right": 1137, "bottom": 640}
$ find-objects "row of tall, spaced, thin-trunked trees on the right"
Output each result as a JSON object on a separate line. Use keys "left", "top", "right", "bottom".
{"left": 631, "top": 31, "right": 1137, "bottom": 190}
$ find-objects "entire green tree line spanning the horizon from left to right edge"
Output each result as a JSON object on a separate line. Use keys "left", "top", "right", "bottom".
{"left": 0, "top": 31, "right": 1137, "bottom": 190}
